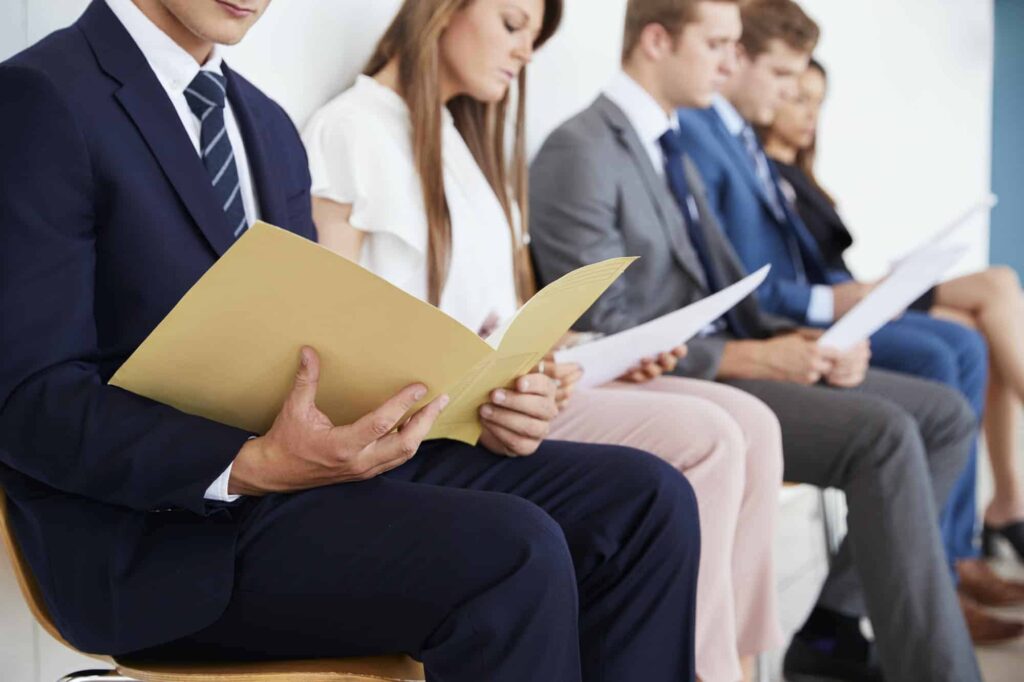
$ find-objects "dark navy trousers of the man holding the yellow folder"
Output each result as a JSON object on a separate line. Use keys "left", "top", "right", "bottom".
{"left": 128, "top": 441, "right": 700, "bottom": 682}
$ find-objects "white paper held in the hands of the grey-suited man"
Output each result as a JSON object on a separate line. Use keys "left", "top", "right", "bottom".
{"left": 818, "top": 245, "right": 968, "bottom": 351}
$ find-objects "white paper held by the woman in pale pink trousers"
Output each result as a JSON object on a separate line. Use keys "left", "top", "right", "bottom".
{"left": 555, "top": 265, "right": 771, "bottom": 388}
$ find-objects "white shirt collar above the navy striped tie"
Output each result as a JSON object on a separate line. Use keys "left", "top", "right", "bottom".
{"left": 106, "top": 0, "right": 223, "bottom": 92}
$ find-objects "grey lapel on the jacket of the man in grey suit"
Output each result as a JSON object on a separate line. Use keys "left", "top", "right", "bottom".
{"left": 597, "top": 95, "right": 708, "bottom": 288}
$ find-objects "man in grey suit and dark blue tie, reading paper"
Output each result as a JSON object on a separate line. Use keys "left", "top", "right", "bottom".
{"left": 530, "top": 0, "right": 980, "bottom": 682}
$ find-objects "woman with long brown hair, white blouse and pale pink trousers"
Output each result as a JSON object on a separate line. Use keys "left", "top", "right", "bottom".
{"left": 304, "top": 0, "right": 781, "bottom": 682}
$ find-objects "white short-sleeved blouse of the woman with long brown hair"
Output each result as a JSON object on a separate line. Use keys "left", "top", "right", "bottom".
{"left": 303, "top": 76, "right": 517, "bottom": 332}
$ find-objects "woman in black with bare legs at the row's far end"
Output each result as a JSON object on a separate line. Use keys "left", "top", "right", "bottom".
{"left": 762, "top": 61, "right": 1024, "bottom": 569}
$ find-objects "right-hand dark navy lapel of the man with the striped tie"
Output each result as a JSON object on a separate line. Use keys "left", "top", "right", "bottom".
{"left": 222, "top": 65, "right": 289, "bottom": 227}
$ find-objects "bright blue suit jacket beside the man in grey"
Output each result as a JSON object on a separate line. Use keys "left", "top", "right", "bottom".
{"left": 679, "top": 104, "right": 839, "bottom": 323}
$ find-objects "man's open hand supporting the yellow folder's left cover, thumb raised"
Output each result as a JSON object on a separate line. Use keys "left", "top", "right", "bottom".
{"left": 228, "top": 347, "right": 449, "bottom": 496}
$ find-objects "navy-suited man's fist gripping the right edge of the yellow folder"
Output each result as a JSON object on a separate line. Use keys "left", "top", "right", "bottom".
{"left": 480, "top": 374, "right": 558, "bottom": 457}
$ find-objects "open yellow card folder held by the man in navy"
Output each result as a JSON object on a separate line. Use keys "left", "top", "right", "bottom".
{"left": 111, "top": 222, "right": 635, "bottom": 444}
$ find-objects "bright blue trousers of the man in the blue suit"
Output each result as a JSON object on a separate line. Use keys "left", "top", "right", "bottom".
{"left": 871, "top": 310, "right": 988, "bottom": 576}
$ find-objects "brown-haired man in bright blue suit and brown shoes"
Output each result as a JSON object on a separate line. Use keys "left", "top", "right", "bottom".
{"left": 679, "top": 0, "right": 1024, "bottom": 641}
